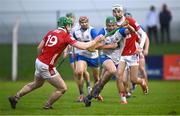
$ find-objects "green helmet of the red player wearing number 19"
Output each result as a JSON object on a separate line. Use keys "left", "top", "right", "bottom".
{"left": 57, "top": 17, "right": 72, "bottom": 28}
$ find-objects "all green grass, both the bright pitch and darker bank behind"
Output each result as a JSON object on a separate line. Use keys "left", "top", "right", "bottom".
{"left": 0, "top": 42, "right": 180, "bottom": 115}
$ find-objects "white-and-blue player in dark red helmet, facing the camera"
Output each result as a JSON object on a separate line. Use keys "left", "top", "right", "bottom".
{"left": 73, "top": 16, "right": 102, "bottom": 102}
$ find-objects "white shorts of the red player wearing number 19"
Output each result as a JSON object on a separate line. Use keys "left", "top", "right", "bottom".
{"left": 34, "top": 59, "right": 59, "bottom": 79}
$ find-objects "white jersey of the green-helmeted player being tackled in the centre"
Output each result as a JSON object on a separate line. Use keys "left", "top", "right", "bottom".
{"left": 103, "top": 28, "right": 124, "bottom": 64}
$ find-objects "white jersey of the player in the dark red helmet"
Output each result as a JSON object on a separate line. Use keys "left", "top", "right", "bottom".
{"left": 75, "top": 26, "right": 98, "bottom": 58}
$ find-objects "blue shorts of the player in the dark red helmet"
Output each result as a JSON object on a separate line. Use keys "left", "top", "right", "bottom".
{"left": 77, "top": 55, "right": 99, "bottom": 68}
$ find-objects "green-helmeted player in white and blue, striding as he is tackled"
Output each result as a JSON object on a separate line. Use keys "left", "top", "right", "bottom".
{"left": 84, "top": 16, "right": 134, "bottom": 107}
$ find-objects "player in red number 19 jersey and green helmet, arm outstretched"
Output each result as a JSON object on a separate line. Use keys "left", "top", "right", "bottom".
{"left": 9, "top": 17, "right": 103, "bottom": 109}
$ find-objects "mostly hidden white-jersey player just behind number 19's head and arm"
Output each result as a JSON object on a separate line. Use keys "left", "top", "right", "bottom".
{"left": 64, "top": 12, "right": 91, "bottom": 102}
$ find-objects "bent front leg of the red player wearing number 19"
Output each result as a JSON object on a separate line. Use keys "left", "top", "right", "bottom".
{"left": 44, "top": 74, "right": 67, "bottom": 109}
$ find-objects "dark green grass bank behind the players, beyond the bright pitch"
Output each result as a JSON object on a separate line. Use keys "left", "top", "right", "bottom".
{"left": 0, "top": 42, "right": 180, "bottom": 80}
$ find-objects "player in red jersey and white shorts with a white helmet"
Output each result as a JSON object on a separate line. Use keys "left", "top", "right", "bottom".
{"left": 112, "top": 4, "right": 148, "bottom": 104}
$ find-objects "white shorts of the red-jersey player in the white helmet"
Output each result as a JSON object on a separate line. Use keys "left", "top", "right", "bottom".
{"left": 120, "top": 54, "right": 139, "bottom": 67}
